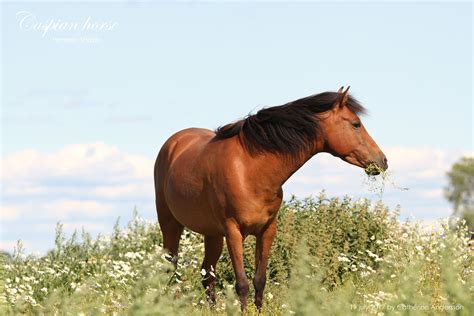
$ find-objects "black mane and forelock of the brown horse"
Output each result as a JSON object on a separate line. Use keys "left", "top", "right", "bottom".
{"left": 214, "top": 92, "right": 366, "bottom": 154}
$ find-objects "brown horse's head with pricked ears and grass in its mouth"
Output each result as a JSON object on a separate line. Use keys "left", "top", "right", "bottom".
{"left": 320, "top": 88, "right": 388, "bottom": 175}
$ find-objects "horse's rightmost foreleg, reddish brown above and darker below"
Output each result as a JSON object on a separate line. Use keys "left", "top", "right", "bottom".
{"left": 253, "top": 219, "right": 276, "bottom": 311}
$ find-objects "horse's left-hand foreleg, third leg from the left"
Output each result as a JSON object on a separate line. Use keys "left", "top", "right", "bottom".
{"left": 225, "top": 223, "right": 249, "bottom": 310}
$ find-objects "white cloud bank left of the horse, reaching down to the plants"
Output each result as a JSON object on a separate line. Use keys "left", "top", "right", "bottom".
{"left": 0, "top": 143, "right": 156, "bottom": 251}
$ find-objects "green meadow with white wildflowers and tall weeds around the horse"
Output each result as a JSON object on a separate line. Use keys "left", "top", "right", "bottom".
{"left": 0, "top": 195, "right": 474, "bottom": 315}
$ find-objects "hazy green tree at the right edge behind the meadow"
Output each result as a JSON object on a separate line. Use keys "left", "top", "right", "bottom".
{"left": 444, "top": 157, "right": 474, "bottom": 232}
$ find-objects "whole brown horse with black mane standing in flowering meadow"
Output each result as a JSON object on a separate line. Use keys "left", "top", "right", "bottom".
{"left": 154, "top": 88, "right": 387, "bottom": 310}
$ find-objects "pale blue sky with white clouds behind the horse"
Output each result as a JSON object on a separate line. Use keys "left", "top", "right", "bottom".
{"left": 1, "top": 2, "right": 473, "bottom": 251}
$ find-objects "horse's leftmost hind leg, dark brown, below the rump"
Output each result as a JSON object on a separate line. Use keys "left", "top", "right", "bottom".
{"left": 156, "top": 202, "right": 184, "bottom": 265}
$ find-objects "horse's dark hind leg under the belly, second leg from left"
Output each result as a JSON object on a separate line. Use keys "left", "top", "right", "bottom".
{"left": 201, "top": 236, "right": 224, "bottom": 305}
